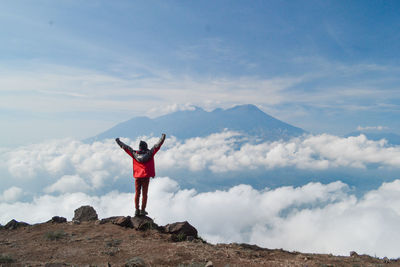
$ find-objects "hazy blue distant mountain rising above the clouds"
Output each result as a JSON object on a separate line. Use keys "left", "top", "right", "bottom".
{"left": 85, "top": 105, "right": 306, "bottom": 142}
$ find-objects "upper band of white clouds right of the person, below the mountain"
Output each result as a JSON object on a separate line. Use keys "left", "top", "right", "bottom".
{"left": 158, "top": 132, "right": 400, "bottom": 173}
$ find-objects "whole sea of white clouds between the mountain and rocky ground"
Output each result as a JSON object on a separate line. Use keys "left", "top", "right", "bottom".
{"left": 0, "top": 131, "right": 400, "bottom": 258}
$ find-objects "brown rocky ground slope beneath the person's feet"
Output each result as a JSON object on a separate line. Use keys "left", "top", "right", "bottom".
{"left": 0, "top": 207, "right": 400, "bottom": 267}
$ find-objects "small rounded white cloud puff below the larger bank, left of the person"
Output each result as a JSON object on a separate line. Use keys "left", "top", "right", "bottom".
{"left": 44, "top": 175, "right": 90, "bottom": 193}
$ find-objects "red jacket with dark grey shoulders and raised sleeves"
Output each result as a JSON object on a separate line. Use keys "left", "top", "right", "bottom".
{"left": 116, "top": 134, "right": 165, "bottom": 178}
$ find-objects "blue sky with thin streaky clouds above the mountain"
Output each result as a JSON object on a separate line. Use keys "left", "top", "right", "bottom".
{"left": 0, "top": 1, "right": 400, "bottom": 146}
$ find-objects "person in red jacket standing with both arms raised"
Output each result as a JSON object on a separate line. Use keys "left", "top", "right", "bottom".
{"left": 115, "top": 134, "right": 165, "bottom": 216}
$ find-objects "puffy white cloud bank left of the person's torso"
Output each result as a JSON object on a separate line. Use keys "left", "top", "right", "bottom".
{"left": 2, "top": 139, "right": 132, "bottom": 189}
